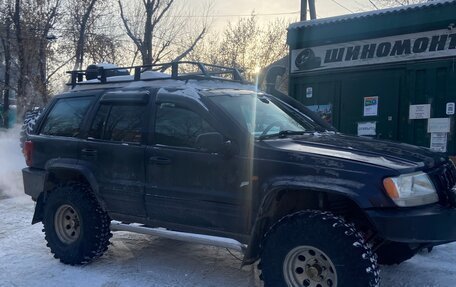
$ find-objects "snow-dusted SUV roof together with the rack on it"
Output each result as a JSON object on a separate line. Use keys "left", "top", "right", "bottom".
{"left": 67, "top": 61, "right": 255, "bottom": 97}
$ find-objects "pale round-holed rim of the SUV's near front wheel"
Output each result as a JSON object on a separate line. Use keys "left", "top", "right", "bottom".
{"left": 283, "top": 246, "right": 337, "bottom": 287}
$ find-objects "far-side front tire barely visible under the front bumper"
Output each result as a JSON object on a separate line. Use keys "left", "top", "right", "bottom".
{"left": 377, "top": 242, "right": 418, "bottom": 265}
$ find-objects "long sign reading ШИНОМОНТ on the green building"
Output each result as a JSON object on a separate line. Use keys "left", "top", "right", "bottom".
{"left": 291, "top": 29, "right": 456, "bottom": 73}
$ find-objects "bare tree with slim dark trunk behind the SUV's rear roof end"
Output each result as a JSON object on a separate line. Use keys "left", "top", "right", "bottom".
{"left": 43, "top": 0, "right": 124, "bottom": 91}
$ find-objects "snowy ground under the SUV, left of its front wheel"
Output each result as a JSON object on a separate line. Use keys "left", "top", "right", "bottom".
{"left": 0, "top": 197, "right": 253, "bottom": 287}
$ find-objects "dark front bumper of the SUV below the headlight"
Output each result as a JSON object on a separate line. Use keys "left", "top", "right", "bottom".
{"left": 366, "top": 204, "right": 456, "bottom": 245}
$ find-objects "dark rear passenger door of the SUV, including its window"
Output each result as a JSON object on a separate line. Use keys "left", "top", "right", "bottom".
{"left": 79, "top": 91, "right": 149, "bottom": 221}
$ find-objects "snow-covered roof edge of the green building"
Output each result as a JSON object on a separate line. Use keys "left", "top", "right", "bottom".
{"left": 288, "top": 0, "right": 456, "bottom": 30}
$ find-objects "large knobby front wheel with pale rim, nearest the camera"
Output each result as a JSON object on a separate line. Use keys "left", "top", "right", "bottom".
{"left": 261, "top": 211, "right": 380, "bottom": 287}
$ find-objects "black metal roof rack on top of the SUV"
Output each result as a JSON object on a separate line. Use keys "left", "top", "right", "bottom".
{"left": 67, "top": 61, "right": 246, "bottom": 88}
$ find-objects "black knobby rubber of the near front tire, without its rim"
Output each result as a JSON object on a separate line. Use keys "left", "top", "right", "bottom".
{"left": 260, "top": 210, "right": 380, "bottom": 287}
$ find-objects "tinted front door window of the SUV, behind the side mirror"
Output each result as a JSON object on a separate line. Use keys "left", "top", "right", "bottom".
{"left": 155, "top": 103, "right": 215, "bottom": 148}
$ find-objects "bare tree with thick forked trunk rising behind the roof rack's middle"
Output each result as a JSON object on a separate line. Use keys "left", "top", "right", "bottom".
{"left": 118, "top": 0, "right": 207, "bottom": 65}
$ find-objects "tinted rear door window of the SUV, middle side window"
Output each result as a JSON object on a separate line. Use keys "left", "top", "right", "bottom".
{"left": 89, "top": 105, "right": 146, "bottom": 143}
